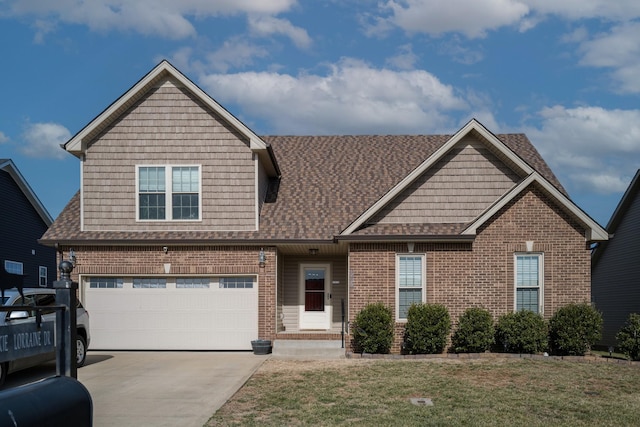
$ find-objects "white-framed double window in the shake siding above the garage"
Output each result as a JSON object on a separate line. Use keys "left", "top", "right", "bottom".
{"left": 137, "top": 166, "right": 201, "bottom": 221}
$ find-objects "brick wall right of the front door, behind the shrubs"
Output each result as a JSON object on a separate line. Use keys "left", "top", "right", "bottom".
{"left": 349, "top": 186, "right": 591, "bottom": 353}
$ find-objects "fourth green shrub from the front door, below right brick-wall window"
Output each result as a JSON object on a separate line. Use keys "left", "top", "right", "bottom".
{"left": 496, "top": 310, "right": 547, "bottom": 354}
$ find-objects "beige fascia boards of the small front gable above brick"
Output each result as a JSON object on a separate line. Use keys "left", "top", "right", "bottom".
{"left": 461, "top": 172, "right": 609, "bottom": 242}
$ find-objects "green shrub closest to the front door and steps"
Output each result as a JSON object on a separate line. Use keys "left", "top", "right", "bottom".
{"left": 352, "top": 302, "right": 394, "bottom": 354}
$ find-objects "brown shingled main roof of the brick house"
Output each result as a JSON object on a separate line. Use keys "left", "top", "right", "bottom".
{"left": 43, "top": 130, "right": 566, "bottom": 243}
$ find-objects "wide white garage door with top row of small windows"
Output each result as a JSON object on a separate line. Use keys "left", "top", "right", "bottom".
{"left": 83, "top": 277, "right": 258, "bottom": 350}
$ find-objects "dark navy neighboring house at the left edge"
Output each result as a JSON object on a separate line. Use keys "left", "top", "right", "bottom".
{"left": 0, "top": 159, "right": 57, "bottom": 287}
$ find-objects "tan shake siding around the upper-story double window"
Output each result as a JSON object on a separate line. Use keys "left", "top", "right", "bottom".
{"left": 82, "top": 79, "right": 258, "bottom": 232}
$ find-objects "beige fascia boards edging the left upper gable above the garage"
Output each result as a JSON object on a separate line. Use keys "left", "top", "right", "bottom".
{"left": 64, "top": 60, "right": 277, "bottom": 171}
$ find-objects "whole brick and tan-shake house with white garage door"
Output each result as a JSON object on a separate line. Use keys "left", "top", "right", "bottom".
{"left": 42, "top": 61, "right": 607, "bottom": 353}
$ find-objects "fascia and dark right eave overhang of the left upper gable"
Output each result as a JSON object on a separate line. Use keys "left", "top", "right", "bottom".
{"left": 63, "top": 60, "right": 280, "bottom": 176}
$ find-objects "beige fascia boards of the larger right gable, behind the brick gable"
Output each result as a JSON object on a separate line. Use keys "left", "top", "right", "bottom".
{"left": 340, "top": 119, "right": 534, "bottom": 236}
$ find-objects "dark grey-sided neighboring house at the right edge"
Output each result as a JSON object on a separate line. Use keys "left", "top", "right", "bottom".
{"left": 591, "top": 169, "right": 640, "bottom": 346}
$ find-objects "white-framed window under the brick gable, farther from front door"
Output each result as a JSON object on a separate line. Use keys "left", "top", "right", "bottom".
{"left": 514, "top": 253, "right": 544, "bottom": 314}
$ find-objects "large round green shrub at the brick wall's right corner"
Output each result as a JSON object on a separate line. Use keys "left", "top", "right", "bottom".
{"left": 549, "top": 303, "right": 602, "bottom": 356}
